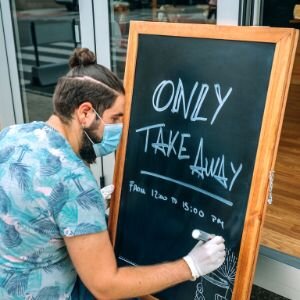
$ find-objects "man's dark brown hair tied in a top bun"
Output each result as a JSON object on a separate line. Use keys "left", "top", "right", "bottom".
{"left": 53, "top": 48, "right": 125, "bottom": 123}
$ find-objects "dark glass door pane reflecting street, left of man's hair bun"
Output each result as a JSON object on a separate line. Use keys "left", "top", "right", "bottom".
{"left": 11, "top": 0, "right": 80, "bottom": 122}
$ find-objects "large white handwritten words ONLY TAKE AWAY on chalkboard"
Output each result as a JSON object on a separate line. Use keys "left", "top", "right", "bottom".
{"left": 136, "top": 78, "right": 243, "bottom": 202}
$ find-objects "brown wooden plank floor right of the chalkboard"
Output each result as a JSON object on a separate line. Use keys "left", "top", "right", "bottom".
{"left": 261, "top": 43, "right": 300, "bottom": 258}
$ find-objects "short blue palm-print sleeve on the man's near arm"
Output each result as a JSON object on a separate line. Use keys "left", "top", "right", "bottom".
{"left": 55, "top": 168, "right": 107, "bottom": 237}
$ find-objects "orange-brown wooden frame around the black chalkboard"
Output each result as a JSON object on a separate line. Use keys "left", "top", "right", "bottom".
{"left": 109, "top": 22, "right": 298, "bottom": 300}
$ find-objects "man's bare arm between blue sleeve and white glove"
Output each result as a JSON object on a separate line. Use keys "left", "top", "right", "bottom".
{"left": 64, "top": 231, "right": 192, "bottom": 299}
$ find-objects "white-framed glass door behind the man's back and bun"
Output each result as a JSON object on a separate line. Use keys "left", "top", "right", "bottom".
{"left": 0, "top": 0, "right": 108, "bottom": 182}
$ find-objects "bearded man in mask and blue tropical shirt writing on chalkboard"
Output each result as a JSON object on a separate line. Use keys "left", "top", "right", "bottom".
{"left": 0, "top": 49, "right": 225, "bottom": 299}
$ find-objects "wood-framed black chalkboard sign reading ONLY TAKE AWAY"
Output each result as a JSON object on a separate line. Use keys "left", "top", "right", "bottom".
{"left": 110, "top": 22, "right": 296, "bottom": 300}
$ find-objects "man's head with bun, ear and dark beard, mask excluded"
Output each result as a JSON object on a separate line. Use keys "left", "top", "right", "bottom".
{"left": 53, "top": 48, "right": 125, "bottom": 163}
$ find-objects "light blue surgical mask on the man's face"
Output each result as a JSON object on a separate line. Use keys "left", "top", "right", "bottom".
{"left": 85, "top": 110, "right": 123, "bottom": 157}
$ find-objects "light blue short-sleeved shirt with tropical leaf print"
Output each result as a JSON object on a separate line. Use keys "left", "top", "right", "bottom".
{"left": 0, "top": 122, "right": 106, "bottom": 300}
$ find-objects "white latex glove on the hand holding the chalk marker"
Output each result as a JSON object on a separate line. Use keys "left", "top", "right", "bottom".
{"left": 183, "top": 236, "right": 225, "bottom": 280}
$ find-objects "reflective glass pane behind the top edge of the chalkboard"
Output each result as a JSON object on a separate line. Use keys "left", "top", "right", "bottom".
{"left": 109, "top": 0, "right": 217, "bottom": 78}
